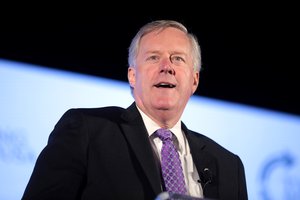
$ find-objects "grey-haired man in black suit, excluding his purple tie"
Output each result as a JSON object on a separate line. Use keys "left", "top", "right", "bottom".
{"left": 23, "top": 20, "right": 247, "bottom": 200}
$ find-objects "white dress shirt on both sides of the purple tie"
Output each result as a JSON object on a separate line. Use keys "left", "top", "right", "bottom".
{"left": 137, "top": 107, "right": 203, "bottom": 198}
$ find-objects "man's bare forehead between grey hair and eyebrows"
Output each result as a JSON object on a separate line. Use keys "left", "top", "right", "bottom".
{"left": 139, "top": 27, "right": 191, "bottom": 54}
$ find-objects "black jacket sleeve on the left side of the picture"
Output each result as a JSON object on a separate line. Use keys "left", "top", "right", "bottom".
{"left": 22, "top": 110, "right": 88, "bottom": 200}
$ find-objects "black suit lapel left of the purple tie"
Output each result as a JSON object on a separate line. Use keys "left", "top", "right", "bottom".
{"left": 121, "top": 103, "right": 162, "bottom": 194}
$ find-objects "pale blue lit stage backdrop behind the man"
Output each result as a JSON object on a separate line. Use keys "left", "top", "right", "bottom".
{"left": 0, "top": 59, "right": 300, "bottom": 200}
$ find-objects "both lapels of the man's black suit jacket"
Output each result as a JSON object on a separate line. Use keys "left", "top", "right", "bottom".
{"left": 121, "top": 103, "right": 219, "bottom": 198}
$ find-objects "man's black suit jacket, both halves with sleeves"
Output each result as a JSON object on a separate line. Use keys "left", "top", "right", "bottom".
{"left": 22, "top": 103, "right": 247, "bottom": 200}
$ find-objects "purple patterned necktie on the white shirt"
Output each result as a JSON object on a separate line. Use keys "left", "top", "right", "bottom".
{"left": 156, "top": 128, "right": 187, "bottom": 194}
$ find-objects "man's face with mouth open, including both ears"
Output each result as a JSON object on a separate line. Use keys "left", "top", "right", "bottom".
{"left": 128, "top": 28, "right": 199, "bottom": 119}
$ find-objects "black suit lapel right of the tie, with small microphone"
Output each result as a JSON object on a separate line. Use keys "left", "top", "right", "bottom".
{"left": 182, "top": 123, "right": 219, "bottom": 198}
